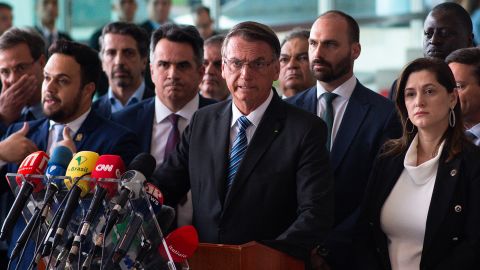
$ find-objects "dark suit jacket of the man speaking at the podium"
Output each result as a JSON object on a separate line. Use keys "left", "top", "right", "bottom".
{"left": 152, "top": 94, "right": 333, "bottom": 258}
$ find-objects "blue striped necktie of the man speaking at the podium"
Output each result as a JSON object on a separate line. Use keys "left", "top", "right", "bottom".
{"left": 227, "top": 116, "right": 252, "bottom": 191}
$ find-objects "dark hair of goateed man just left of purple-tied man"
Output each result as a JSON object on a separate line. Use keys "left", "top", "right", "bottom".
{"left": 99, "top": 22, "right": 148, "bottom": 57}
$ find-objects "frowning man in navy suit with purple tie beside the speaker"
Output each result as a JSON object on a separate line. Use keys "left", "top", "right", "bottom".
{"left": 112, "top": 24, "right": 214, "bottom": 225}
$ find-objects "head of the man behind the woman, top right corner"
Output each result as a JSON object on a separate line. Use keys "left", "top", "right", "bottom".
{"left": 389, "top": 2, "right": 473, "bottom": 100}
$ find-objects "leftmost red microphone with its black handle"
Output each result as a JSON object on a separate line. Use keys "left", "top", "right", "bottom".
{"left": 0, "top": 151, "right": 49, "bottom": 241}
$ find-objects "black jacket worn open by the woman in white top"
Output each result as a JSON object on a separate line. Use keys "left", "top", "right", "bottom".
{"left": 355, "top": 143, "right": 480, "bottom": 270}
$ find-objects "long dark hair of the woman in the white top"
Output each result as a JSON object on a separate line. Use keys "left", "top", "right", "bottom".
{"left": 383, "top": 58, "right": 466, "bottom": 161}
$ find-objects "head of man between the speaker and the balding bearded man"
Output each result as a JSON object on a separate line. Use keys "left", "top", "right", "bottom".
{"left": 278, "top": 29, "right": 315, "bottom": 97}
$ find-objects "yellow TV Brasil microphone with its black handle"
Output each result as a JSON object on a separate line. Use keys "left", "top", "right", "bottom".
{"left": 52, "top": 151, "right": 98, "bottom": 247}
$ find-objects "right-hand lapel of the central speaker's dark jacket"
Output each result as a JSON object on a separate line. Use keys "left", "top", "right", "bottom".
{"left": 224, "top": 94, "right": 285, "bottom": 210}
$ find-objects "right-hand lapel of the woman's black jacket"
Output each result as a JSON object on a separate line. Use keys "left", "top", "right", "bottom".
{"left": 422, "top": 150, "right": 461, "bottom": 256}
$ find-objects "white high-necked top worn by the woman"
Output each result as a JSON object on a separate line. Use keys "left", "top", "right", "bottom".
{"left": 380, "top": 134, "right": 445, "bottom": 270}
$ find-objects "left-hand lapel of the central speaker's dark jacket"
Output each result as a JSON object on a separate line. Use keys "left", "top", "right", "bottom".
{"left": 214, "top": 101, "right": 232, "bottom": 203}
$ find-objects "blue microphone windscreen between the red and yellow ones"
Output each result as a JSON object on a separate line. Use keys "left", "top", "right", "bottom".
{"left": 45, "top": 145, "right": 73, "bottom": 186}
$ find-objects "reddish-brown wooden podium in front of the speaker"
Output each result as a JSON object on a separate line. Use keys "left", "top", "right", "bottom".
{"left": 188, "top": 242, "right": 305, "bottom": 270}
